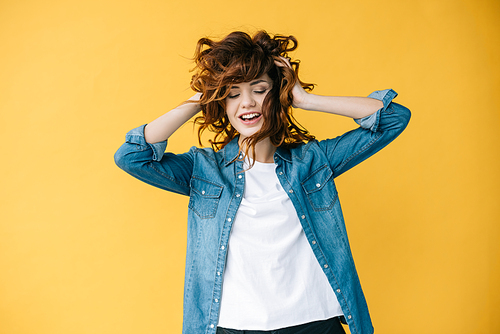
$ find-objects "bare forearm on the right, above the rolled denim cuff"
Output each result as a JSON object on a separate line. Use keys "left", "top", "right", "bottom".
{"left": 299, "top": 93, "right": 383, "bottom": 118}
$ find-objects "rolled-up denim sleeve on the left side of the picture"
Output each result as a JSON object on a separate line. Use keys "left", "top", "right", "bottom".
{"left": 114, "top": 125, "right": 196, "bottom": 195}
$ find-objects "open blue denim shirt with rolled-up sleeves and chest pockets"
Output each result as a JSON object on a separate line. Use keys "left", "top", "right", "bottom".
{"left": 115, "top": 89, "right": 410, "bottom": 334}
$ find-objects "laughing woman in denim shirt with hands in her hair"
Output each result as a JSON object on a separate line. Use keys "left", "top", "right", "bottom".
{"left": 115, "top": 31, "right": 410, "bottom": 334}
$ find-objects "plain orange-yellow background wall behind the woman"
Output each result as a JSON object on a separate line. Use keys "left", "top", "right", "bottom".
{"left": 0, "top": 0, "right": 500, "bottom": 334}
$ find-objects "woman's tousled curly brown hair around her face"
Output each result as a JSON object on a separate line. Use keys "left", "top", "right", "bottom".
{"left": 191, "top": 31, "right": 315, "bottom": 159}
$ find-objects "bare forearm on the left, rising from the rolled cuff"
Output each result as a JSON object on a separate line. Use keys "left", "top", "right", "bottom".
{"left": 144, "top": 94, "right": 200, "bottom": 144}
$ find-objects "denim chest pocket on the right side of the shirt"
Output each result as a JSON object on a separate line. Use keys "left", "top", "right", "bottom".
{"left": 302, "top": 165, "right": 337, "bottom": 211}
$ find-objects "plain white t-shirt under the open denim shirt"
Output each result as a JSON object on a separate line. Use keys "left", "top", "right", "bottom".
{"left": 218, "top": 161, "right": 343, "bottom": 330}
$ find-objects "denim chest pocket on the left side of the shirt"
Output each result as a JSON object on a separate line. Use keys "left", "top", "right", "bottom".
{"left": 189, "top": 177, "right": 224, "bottom": 219}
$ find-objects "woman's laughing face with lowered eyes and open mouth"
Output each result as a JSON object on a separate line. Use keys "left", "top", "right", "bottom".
{"left": 226, "top": 74, "right": 273, "bottom": 140}
